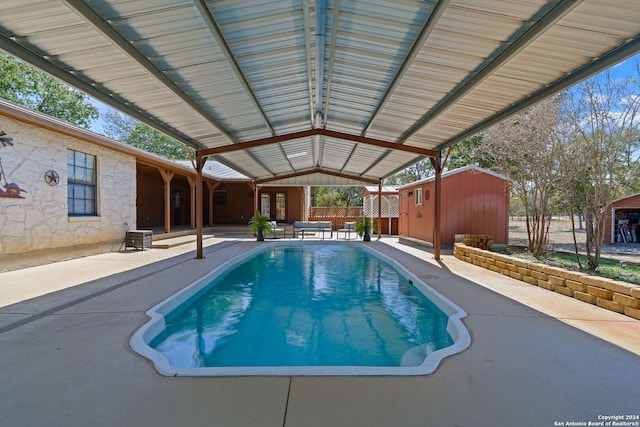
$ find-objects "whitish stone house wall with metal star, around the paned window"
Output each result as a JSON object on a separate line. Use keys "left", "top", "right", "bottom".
{"left": 0, "top": 116, "right": 136, "bottom": 255}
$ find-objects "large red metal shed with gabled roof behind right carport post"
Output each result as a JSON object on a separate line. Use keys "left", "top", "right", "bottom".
{"left": 398, "top": 165, "right": 509, "bottom": 245}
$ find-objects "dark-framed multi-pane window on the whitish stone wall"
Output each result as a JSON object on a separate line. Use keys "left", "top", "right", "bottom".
{"left": 67, "top": 150, "right": 98, "bottom": 216}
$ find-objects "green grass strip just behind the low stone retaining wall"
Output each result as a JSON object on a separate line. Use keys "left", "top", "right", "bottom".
{"left": 495, "top": 247, "right": 640, "bottom": 285}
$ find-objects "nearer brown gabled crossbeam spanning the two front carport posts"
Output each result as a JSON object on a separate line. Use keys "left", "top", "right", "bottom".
{"left": 197, "top": 129, "right": 438, "bottom": 157}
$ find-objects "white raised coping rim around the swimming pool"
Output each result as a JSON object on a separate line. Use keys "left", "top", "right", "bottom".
{"left": 129, "top": 241, "right": 471, "bottom": 377}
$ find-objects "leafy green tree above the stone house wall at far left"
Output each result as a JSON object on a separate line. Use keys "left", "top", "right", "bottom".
{"left": 0, "top": 53, "right": 99, "bottom": 128}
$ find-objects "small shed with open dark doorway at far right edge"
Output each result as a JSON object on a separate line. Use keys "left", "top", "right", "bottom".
{"left": 603, "top": 193, "right": 640, "bottom": 244}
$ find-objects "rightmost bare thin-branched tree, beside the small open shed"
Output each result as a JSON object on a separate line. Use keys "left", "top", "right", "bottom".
{"left": 561, "top": 63, "right": 640, "bottom": 270}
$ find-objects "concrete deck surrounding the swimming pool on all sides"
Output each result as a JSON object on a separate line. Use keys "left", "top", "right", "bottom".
{"left": 0, "top": 237, "right": 640, "bottom": 427}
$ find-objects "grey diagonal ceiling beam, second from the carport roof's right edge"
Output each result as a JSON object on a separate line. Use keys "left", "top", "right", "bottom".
{"left": 398, "top": 0, "right": 582, "bottom": 143}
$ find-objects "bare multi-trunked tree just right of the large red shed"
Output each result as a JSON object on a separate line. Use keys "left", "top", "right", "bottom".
{"left": 480, "top": 97, "right": 559, "bottom": 256}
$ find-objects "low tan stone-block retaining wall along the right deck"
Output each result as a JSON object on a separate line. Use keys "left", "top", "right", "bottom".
{"left": 453, "top": 243, "right": 640, "bottom": 319}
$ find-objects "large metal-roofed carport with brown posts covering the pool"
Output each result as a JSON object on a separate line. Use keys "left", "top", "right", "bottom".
{"left": 0, "top": 0, "right": 640, "bottom": 258}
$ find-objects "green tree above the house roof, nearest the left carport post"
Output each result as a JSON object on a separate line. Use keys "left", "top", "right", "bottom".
{"left": 104, "top": 111, "right": 189, "bottom": 160}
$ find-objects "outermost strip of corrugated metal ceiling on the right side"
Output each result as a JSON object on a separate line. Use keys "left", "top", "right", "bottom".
{"left": 414, "top": 1, "right": 640, "bottom": 147}
